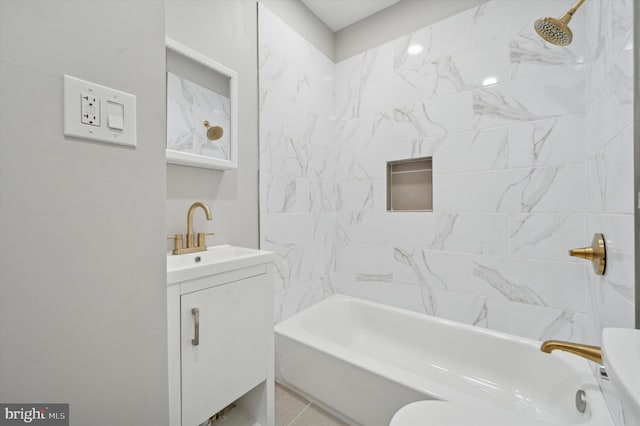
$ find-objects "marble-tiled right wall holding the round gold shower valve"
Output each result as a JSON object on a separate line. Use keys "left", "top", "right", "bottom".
{"left": 584, "top": 0, "right": 637, "bottom": 340}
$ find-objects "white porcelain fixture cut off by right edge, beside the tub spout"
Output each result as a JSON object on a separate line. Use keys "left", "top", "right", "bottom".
{"left": 602, "top": 328, "right": 640, "bottom": 425}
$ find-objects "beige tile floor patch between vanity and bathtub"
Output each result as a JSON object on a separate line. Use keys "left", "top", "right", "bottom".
{"left": 276, "top": 383, "right": 348, "bottom": 426}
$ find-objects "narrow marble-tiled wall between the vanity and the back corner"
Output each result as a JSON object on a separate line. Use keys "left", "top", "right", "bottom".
{"left": 258, "top": 4, "right": 337, "bottom": 322}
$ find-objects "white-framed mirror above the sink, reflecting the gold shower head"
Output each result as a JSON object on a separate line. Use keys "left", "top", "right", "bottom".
{"left": 166, "top": 38, "right": 238, "bottom": 170}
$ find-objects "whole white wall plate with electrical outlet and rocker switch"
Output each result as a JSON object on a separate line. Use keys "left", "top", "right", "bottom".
{"left": 64, "top": 75, "right": 136, "bottom": 148}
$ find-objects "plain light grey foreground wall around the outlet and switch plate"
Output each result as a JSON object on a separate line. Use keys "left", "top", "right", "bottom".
{"left": 0, "top": 0, "right": 168, "bottom": 426}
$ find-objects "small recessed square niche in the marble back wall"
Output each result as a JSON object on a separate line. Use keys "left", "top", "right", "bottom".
{"left": 387, "top": 157, "right": 433, "bottom": 212}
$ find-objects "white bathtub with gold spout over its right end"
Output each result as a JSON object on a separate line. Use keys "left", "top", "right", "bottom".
{"left": 275, "top": 295, "right": 612, "bottom": 426}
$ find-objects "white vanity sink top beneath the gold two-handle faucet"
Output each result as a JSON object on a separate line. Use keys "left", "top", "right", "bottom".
{"left": 167, "top": 245, "right": 273, "bottom": 284}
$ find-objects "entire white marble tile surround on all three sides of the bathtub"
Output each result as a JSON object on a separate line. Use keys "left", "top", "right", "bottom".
{"left": 260, "top": 0, "right": 633, "bottom": 342}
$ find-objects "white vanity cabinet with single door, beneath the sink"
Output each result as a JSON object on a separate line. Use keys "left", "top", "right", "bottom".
{"left": 167, "top": 248, "right": 274, "bottom": 426}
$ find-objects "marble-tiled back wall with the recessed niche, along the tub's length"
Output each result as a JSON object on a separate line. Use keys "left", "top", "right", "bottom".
{"left": 333, "top": 0, "right": 595, "bottom": 341}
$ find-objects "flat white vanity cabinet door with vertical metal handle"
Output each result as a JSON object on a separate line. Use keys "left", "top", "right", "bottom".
{"left": 180, "top": 275, "right": 270, "bottom": 426}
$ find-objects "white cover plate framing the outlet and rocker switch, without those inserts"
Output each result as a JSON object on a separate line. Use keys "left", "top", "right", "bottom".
{"left": 64, "top": 75, "right": 136, "bottom": 148}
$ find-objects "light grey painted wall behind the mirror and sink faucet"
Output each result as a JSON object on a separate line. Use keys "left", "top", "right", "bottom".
{"left": 165, "top": 0, "right": 258, "bottom": 250}
